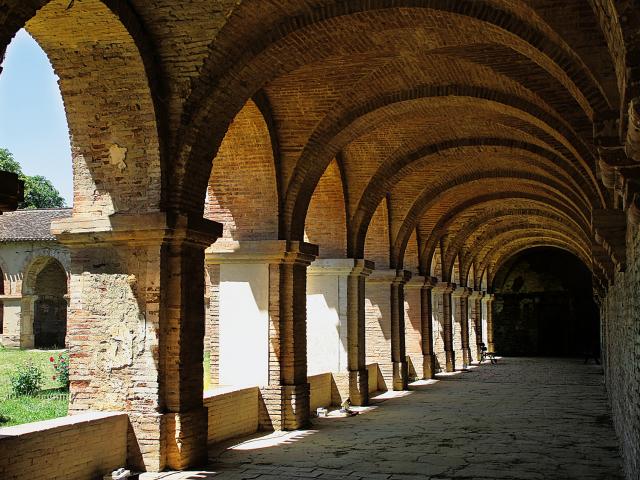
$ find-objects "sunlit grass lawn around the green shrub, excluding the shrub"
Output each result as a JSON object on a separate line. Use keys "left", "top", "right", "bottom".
{"left": 0, "top": 348, "right": 68, "bottom": 427}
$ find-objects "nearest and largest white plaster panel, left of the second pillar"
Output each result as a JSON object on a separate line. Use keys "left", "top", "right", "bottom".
{"left": 220, "top": 264, "right": 269, "bottom": 386}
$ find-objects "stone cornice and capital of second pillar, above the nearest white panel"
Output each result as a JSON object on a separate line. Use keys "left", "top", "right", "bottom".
{"left": 205, "top": 240, "right": 318, "bottom": 265}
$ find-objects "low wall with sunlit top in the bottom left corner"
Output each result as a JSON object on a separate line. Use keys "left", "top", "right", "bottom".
{"left": 0, "top": 412, "right": 128, "bottom": 480}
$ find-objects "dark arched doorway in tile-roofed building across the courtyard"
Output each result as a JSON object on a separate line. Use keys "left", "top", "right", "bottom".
{"left": 24, "top": 257, "right": 67, "bottom": 348}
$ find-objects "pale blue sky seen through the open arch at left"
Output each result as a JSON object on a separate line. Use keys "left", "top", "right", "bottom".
{"left": 0, "top": 30, "right": 73, "bottom": 206}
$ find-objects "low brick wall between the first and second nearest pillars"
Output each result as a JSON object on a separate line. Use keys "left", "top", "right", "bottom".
{"left": 204, "top": 387, "right": 260, "bottom": 444}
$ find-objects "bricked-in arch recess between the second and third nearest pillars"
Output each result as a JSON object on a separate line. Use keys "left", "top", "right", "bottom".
{"left": 305, "top": 159, "right": 347, "bottom": 258}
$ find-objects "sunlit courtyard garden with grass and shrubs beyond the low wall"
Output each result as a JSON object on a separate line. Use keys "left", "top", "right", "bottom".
{"left": 0, "top": 348, "right": 69, "bottom": 428}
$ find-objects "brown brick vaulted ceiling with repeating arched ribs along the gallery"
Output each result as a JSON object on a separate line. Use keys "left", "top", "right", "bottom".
{"left": 0, "top": 0, "right": 638, "bottom": 284}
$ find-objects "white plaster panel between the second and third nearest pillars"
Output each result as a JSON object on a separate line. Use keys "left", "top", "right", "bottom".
{"left": 307, "top": 275, "right": 347, "bottom": 375}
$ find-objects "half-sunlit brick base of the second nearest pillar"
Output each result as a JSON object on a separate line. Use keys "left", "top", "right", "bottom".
{"left": 259, "top": 383, "right": 309, "bottom": 430}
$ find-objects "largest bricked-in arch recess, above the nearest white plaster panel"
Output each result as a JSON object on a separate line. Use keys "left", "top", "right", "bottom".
{"left": 205, "top": 100, "right": 280, "bottom": 246}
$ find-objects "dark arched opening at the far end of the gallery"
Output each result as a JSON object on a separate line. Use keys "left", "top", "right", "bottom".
{"left": 493, "top": 247, "right": 600, "bottom": 357}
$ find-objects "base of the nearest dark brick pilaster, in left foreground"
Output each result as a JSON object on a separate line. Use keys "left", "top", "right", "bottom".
{"left": 163, "top": 407, "right": 209, "bottom": 470}
